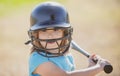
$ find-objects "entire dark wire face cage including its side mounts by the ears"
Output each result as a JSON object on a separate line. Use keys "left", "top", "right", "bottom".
{"left": 25, "top": 27, "right": 73, "bottom": 57}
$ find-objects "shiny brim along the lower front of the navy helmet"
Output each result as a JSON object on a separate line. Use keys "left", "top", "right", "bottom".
{"left": 30, "top": 23, "right": 70, "bottom": 31}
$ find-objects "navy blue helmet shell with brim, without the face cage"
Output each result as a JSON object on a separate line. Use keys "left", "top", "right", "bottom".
{"left": 30, "top": 2, "right": 70, "bottom": 30}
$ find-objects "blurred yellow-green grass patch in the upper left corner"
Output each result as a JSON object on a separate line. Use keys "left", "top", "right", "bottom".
{"left": 0, "top": 0, "right": 46, "bottom": 16}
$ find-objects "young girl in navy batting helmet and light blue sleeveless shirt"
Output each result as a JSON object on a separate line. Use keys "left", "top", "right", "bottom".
{"left": 28, "top": 2, "right": 107, "bottom": 76}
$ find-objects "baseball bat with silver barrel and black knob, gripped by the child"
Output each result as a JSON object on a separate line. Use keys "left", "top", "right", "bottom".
{"left": 71, "top": 41, "right": 113, "bottom": 74}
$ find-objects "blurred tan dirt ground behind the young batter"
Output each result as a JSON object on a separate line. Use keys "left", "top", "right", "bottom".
{"left": 0, "top": 0, "right": 120, "bottom": 76}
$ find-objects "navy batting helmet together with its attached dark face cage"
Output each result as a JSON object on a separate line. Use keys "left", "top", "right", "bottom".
{"left": 28, "top": 2, "right": 73, "bottom": 57}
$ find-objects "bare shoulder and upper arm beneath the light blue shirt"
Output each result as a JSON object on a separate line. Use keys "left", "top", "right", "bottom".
{"left": 33, "top": 62, "right": 67, "bottom": 76}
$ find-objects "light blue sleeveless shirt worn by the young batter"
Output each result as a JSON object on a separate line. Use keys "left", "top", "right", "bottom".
{"left": 29, "top": 52, "right": 75, "bottom": 76}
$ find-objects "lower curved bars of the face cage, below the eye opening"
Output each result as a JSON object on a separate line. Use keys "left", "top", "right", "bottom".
{"left": 31, "top": 35, "right": 72, "bottom": 57}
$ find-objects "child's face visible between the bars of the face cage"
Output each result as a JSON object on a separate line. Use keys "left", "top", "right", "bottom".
{"left": 39, "top": 28, "right": 64, "bottom": 52}
